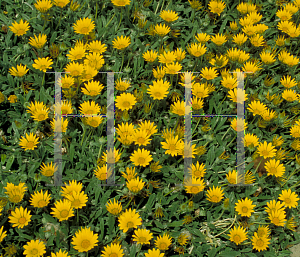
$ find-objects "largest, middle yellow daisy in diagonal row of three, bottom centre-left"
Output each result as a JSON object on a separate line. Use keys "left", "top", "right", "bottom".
{"left": 119, "top": 209, "right": 142, "bottom": 233}
